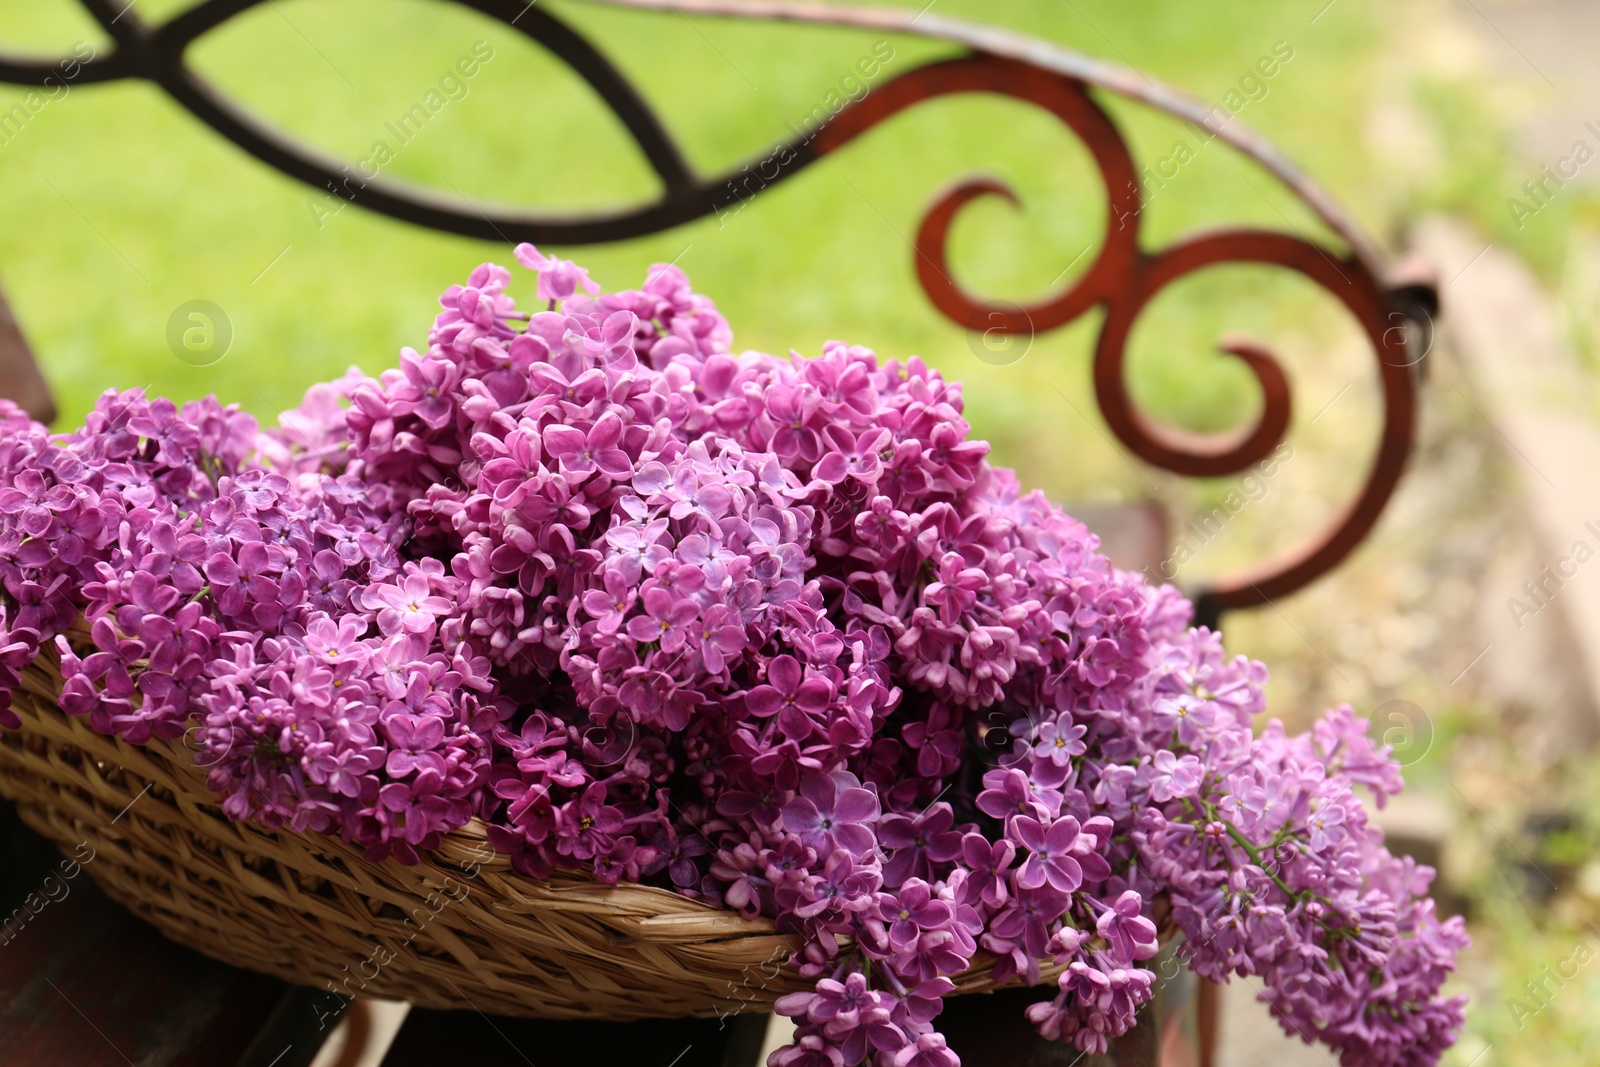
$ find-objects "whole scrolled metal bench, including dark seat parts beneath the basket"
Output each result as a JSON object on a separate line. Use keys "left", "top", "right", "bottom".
{"left": 0, "top": 0, "right": 1438, "bottom": 1067}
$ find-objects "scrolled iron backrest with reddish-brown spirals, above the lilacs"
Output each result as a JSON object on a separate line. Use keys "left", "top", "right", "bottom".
{"left": 0, "top": 0, "right": 1437, "bottom": 625}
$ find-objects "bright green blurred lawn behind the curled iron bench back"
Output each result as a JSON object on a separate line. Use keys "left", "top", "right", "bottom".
{"left": 0, "top": 0, "right": 1389, "bottom": 511}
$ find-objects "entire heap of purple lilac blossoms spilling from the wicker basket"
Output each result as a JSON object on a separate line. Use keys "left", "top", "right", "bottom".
{"left": 0, "top": 252, "right": 1466, "bottom": 1067}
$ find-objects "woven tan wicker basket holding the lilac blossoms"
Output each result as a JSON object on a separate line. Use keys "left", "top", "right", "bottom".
{"left": 0, "top": 648, "right": 1024, "bottom": 1021}
